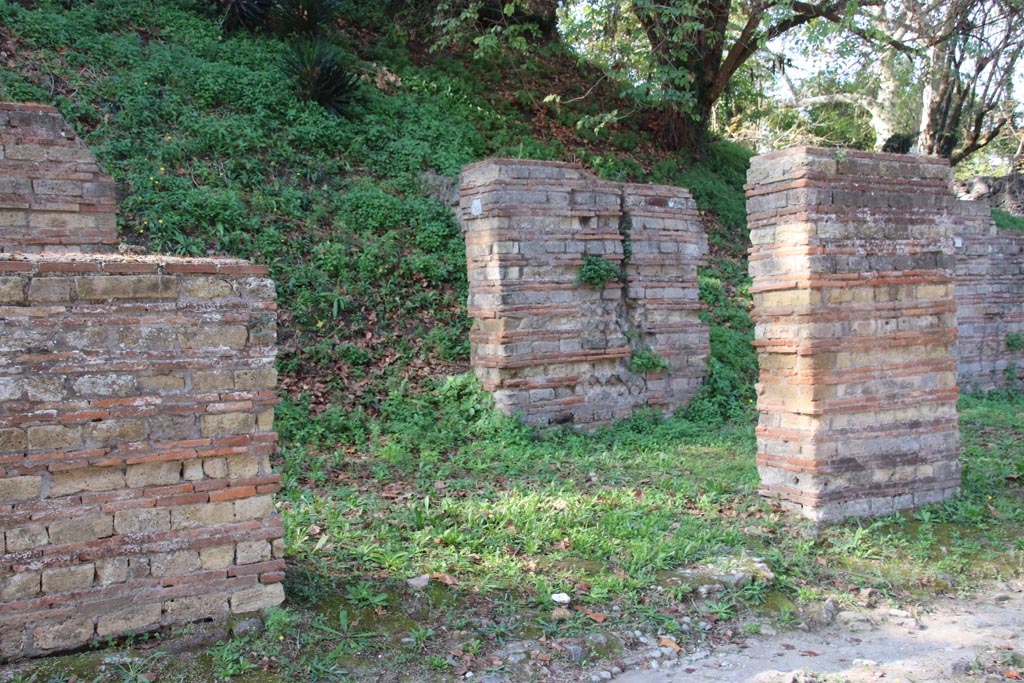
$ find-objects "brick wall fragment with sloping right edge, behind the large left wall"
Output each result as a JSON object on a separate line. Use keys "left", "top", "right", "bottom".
{"left": 0, "top": 102, "right": 118, "bottom": 252}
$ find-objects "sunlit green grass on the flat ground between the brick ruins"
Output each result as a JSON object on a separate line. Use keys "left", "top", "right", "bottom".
{"left": 9, "top": 393, "right": 1024, "bottom": 683}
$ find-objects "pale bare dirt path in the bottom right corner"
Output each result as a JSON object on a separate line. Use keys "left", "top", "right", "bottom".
{"left": 606, "top": 581, "right": 1024, "bottom": 683}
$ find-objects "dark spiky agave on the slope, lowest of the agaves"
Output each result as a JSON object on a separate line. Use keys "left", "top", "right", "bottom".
{"left": 285, "top": 39, "right": 359, "bottom": 115}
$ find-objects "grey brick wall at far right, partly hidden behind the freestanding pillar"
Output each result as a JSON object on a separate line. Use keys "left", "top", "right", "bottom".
{"left": 956, "top": 202, "right": 1024, "bottom": 390}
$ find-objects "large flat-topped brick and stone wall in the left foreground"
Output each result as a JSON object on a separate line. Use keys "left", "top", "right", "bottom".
{"left": 0, "top": 105, "right": 285, "bottom": 663}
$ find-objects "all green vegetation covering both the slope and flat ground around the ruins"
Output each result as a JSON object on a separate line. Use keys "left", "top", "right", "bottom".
{"left": 0, "top": 0, "right": 1024, "bottom": 681}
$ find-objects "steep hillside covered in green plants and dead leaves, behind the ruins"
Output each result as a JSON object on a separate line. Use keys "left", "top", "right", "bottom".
{"left": 0, "top": 0, "right": 753, "bottom": 429}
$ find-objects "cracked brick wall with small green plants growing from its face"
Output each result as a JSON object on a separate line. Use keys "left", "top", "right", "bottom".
{"left": 459, "top": 159, "right": 709, "bottom": 428}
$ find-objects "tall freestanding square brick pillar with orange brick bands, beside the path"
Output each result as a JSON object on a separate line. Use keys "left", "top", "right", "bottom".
{"left": 748, "top": 147, "right": 959, "bottom": 521}
